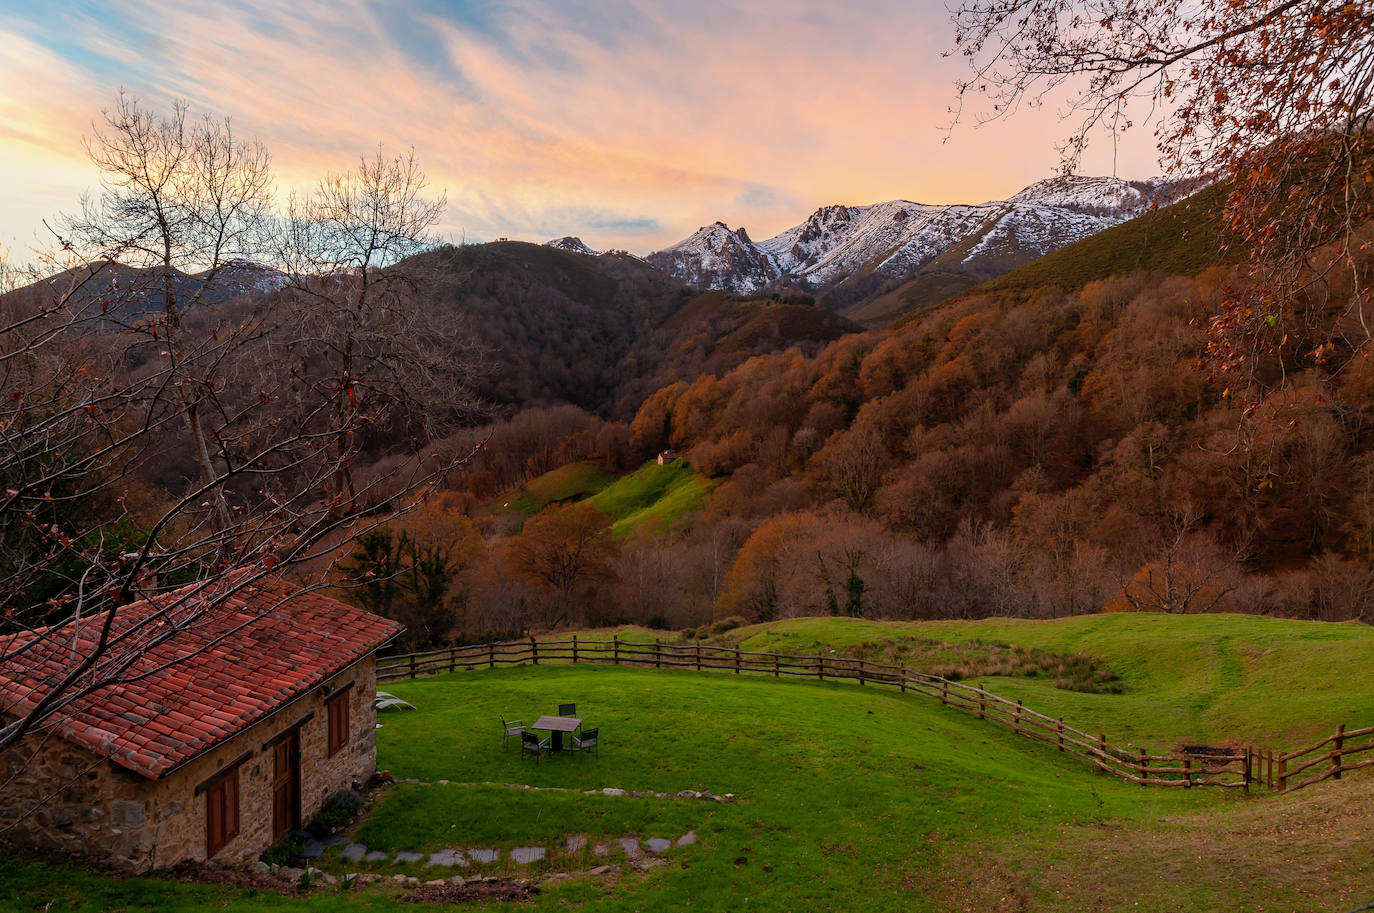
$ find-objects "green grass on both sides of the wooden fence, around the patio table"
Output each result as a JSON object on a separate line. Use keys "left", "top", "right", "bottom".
{"left": 0, "top": 616, "right": 1374, "bottom": 913}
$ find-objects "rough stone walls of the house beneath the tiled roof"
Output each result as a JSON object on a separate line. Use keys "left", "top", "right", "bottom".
{"left": 0, "top": 656, "right": 376, "bottom": 872}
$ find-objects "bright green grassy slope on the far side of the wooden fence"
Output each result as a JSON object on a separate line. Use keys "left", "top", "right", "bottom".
{"left": 727, "top": 613, "right": 1374, "bottom": 748}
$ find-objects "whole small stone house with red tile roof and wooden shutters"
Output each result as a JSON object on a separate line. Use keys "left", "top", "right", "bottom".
{"left": 0, "top": 576, "right": 403, "bottom": 872}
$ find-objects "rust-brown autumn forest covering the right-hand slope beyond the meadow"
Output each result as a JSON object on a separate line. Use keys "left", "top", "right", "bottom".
{"left": 376, "top": 199, "right": 1374, "bottom": 637}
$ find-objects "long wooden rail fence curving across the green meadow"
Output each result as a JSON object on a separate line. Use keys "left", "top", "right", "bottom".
{"left": 376, "top": 635, "right": 1374, "bottom": 792}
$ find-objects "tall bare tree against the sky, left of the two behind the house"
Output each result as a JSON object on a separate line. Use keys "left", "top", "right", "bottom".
{"left": 54, "top": 92, "right": 273, "bottom": 525}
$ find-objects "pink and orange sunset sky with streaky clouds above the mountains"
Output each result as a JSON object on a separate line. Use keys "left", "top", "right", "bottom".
{"left": 0, "top": 0, "right": 1158, "bottom": 254}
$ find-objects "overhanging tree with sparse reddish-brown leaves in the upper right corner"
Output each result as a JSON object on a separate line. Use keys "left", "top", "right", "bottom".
{"left": 951, "top": 0, "right": 1374, "bottom": 400}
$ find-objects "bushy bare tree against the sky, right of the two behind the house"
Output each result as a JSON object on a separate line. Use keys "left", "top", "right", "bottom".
{"left": 283, "top": 149, "right": 482, "bottom": 510}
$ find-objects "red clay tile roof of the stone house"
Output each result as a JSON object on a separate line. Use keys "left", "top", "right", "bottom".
{"left": 0, "top": 575, "right": 404, "bottom": 780}
